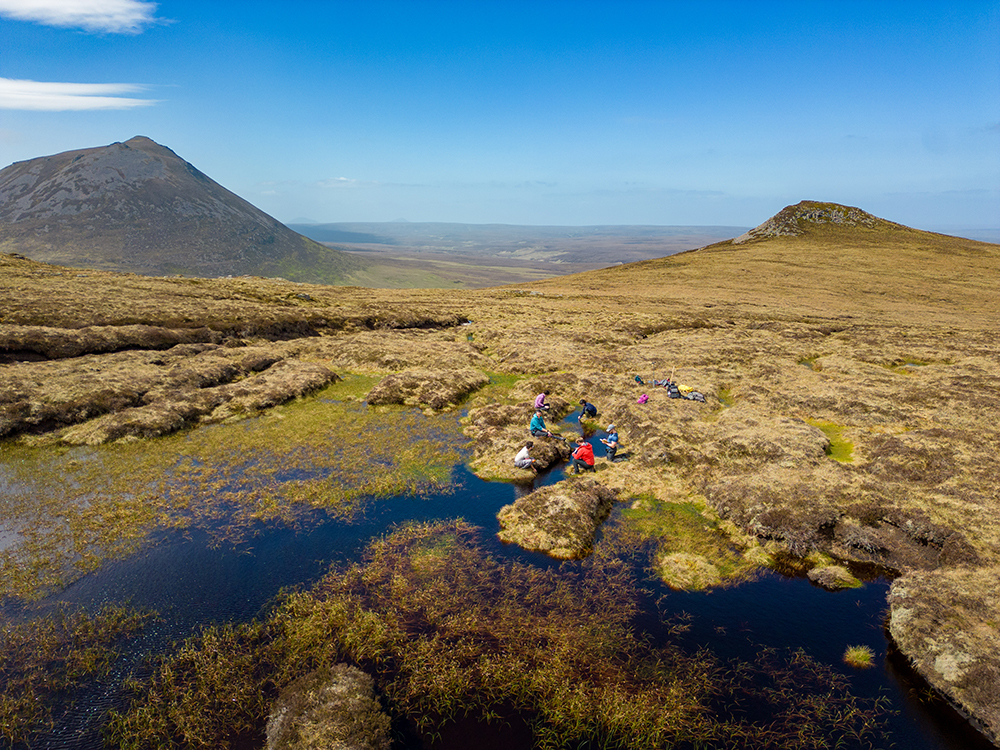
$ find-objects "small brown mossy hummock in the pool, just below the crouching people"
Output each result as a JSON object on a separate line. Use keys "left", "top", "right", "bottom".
{"left": 497, "top": 480, "right": 616, "bottom": 560}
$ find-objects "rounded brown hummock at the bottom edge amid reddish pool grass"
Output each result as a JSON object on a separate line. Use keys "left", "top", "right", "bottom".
{"left": 267, "top": 664, "right": 391, "bottom": 750}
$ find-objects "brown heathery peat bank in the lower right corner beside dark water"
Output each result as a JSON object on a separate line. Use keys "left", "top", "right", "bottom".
{"left": 889, "top": 568, "right": 1000, "bottom": 745}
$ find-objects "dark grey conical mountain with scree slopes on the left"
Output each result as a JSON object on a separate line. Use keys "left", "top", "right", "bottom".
{"left": 0, "top": 136, "right": 363, "bottom": 283}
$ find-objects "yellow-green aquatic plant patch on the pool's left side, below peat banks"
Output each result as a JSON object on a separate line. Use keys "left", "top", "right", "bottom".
{"left": 0, "top": 376, "right": 462, "bottom": 599}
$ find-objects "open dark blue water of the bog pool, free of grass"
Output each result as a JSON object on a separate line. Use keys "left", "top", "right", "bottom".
{"left": 7, "top": 456, "right": 991, "bottom": 750}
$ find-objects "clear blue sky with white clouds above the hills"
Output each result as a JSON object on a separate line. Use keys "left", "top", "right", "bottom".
{"left": 0, "top": 0, "right": 1000, "bottom": 231}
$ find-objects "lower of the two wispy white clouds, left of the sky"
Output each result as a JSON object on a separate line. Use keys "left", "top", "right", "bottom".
{"left": 0, "top": 78, "right": 157, "bottom": 112}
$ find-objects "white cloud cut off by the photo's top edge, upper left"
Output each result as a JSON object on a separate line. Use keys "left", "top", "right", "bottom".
{"left": 0, "top": 0, "right": 159, "bottom": 34}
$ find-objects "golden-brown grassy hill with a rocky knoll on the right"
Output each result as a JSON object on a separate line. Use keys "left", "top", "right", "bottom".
{"left": 535, "top": 201, "right": 1000, "bottom": 327}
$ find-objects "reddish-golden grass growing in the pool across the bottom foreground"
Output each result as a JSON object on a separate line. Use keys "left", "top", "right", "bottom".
{"left": 109, "top": 521, "right": 883, "bottom": 748}
